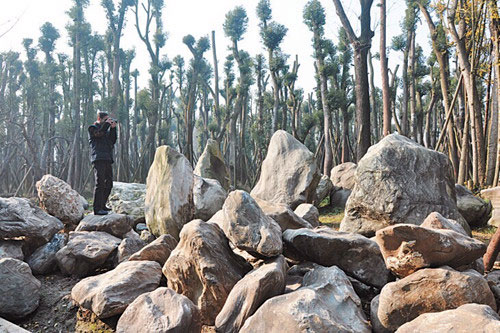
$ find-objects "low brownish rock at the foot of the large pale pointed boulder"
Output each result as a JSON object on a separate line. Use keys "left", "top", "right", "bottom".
{"left": 255, "top": 199, "right": 314, "bottom": 231}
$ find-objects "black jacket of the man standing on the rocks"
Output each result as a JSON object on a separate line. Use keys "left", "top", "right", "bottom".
{"left": 89, "top": 122, "right": 116, "bottom": 163}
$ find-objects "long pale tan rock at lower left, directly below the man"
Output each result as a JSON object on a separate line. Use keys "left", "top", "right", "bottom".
{"left": 71, "top": 261, "right": 161, "bottom": 319}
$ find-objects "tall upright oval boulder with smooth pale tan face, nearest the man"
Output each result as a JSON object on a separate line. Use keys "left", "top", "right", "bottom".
{"left": 145, "top": 146, "right": 194, "bottom": 239}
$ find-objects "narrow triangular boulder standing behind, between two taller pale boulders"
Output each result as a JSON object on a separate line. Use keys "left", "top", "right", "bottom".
{"left": 194, "top": 139, "right": 230, "bottom": 191}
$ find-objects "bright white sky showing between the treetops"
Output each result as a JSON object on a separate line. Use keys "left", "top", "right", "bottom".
{"left": 0, "top": 0, "right": 431, "bottom": 93}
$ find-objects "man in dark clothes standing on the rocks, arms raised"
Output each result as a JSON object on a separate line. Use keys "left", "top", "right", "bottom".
{"left": 89, "top": 111, "right": 116, "bottom": 215}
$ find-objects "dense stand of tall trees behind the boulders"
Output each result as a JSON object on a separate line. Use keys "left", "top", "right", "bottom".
{"left": 0, "top": 0, "right": 500, "bottom": 196}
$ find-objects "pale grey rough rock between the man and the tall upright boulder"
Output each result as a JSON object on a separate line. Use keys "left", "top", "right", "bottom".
{"left": 108, "top": 182, "right": 146, "bottom": 225}
